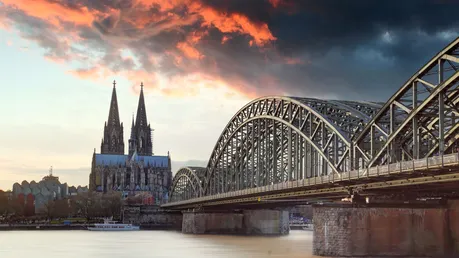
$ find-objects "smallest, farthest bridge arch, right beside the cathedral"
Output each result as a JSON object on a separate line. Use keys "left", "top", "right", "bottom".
{"left": 169, "top": 167, "right": 206, "bottom": 202}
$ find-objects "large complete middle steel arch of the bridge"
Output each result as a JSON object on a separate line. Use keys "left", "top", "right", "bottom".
{"left": 204, "top": 96, "right": 378, "bottom": 195}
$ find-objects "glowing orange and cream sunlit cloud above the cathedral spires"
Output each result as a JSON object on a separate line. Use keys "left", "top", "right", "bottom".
{"left": 0, "top": 0, "right": 284, "bottom": 100}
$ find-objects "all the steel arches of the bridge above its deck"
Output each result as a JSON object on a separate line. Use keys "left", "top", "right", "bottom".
{"left": 169, "top": 38, "right": 459, "bottom": 208}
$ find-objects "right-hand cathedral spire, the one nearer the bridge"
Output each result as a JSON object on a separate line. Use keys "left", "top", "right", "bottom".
{"left": 129, "top": 83, "right": 153, "bottom": 156}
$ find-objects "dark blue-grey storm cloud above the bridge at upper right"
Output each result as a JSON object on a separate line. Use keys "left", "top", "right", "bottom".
{"left": 198, "top": 0, "right": 459, "bottom": 98}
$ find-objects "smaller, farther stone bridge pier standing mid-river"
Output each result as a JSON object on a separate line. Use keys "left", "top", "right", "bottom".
{"left": 182, "top": 210, "right": 289, "bottom": 235}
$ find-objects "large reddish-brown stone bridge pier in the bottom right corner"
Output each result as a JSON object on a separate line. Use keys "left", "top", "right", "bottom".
{"left": 313, "top": 201, "right": 459, "bottom": 257}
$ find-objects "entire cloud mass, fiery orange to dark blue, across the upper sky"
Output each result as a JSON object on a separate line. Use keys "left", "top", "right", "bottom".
{"left": 0, "top": 0, "right": 459, "bottom": 100}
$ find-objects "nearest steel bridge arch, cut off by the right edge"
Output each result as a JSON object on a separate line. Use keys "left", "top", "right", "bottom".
{"left": 352, "top": 38, "right": 459, "bottom": 169}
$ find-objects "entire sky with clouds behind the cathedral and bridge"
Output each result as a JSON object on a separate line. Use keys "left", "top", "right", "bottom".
{"left": 0, "top": 0, "right": 459, "bottom": 189}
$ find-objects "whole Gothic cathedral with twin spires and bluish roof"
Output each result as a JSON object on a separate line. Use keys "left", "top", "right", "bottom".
{"left": 89, "top": 82, "right": 172, "bottom": 203}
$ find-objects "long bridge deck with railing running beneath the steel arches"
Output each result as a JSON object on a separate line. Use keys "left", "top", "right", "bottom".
{"left": 162, "top": 153, "right": 459, "bottom": 209}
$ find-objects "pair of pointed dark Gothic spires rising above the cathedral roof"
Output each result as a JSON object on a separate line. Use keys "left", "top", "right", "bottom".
{"left": 101, "top": 82, "right": 153, "bottom": 156}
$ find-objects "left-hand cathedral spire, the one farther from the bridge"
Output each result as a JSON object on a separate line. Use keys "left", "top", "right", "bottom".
{"left": 100, "top": 81, "right": 124, "bottom": 155}
